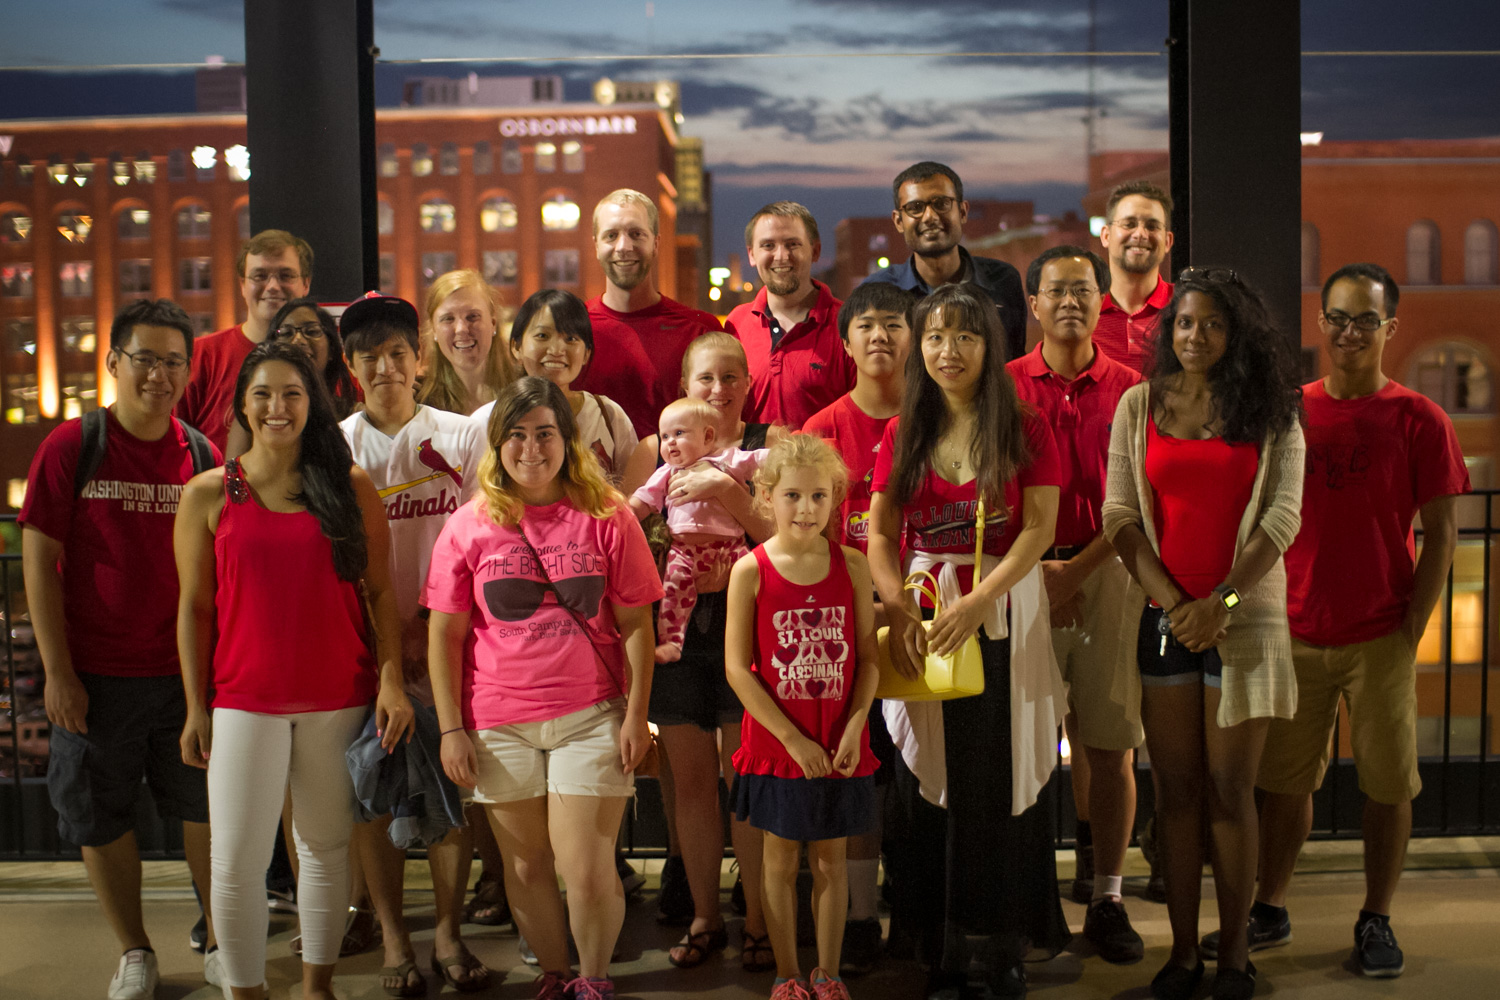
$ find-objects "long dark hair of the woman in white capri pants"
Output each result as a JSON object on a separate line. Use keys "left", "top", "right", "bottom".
{"left": 234, "top": 340, "right": 369, "bottom": 583}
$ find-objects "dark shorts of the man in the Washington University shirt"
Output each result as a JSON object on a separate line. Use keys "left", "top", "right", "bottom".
{"left": 47, "top": 672, "right": 209, "bottom": 847}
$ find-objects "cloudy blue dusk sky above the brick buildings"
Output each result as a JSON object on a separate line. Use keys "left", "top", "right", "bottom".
{"left": 0, "top": 0, "right": 1500, "bottom": 264}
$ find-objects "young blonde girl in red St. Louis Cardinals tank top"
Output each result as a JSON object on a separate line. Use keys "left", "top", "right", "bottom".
{"left": 725, "top": 433, "right": 878, "bottom": 1000}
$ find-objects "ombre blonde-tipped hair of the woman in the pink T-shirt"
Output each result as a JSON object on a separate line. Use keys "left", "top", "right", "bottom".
{"left": 474, "top": 375, "right": 626, "bottom": 526}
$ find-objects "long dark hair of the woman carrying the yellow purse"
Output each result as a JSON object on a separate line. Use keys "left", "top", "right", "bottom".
{"left": 891, "top": 282, "right": 1031, "bottom": 516}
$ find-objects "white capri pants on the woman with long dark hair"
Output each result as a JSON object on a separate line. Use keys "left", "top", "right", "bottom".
{"left": 209, "top": 706, "right": 369, "bottom": 988}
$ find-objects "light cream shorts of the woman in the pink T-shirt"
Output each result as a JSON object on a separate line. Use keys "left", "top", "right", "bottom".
{"left": 470, "top": 699, "right": 636, "bottom": 805}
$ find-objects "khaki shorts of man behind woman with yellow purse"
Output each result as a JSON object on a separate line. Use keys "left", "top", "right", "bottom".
{"left": 1052, "top": 558, "right": 1145, "bottom": 750}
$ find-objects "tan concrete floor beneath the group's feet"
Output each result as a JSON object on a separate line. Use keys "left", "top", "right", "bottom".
{"left": 0, "top": 838, "right": 1500, "bottom": 1000}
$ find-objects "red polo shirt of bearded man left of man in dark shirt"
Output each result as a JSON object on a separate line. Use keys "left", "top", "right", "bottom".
{"left": 725, "top": 282, "right": 857, "bottom": 430}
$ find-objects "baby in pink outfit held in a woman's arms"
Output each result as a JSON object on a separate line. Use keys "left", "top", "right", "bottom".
{"left": 630, "top": 399, "right": 765, "bottom": 663}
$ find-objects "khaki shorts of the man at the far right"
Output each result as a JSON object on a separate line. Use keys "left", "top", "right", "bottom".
{"left": 1256, "top": 631, "right": 1422, "bottom": 805}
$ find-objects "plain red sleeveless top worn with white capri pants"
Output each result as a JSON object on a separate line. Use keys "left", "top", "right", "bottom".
{"left": 213, "top": 459, "right": 377, "bottom": 715}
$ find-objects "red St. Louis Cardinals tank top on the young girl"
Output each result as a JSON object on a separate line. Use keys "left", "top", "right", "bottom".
{"left": 734, "top": 543, "right": 879, "bottom": 778}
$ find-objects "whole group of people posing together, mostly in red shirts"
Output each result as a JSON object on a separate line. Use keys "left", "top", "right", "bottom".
{"left": 21, "top": 162, "right": 1469, "bottom": 1000}
